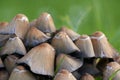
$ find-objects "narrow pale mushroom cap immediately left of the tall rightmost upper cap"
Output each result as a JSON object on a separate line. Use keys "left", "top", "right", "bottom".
{"left": 75, "top": 35, "right": 95, "bottom": 58}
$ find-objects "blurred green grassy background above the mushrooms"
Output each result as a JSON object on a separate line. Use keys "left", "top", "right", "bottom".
{"left": 0, "top": 0, "right": 120, "bottom": 51}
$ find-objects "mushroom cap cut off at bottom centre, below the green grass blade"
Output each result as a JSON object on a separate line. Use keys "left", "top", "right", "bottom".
{"left": 54, "top": 69, "right": 77, "bottom": 80}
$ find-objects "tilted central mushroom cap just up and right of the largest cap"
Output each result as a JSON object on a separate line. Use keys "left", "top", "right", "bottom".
{"left": 51, "top": 31, "right": 80, "bottom": 54}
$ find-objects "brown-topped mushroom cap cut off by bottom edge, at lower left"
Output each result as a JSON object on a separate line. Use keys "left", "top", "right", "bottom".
{"left": 9, "top": 66, "right": 36, "bottom": 80}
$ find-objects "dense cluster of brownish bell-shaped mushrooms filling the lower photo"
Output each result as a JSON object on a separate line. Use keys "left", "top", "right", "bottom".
{"left": 0, "top": 12, "right": 120, "bottom": 80}
